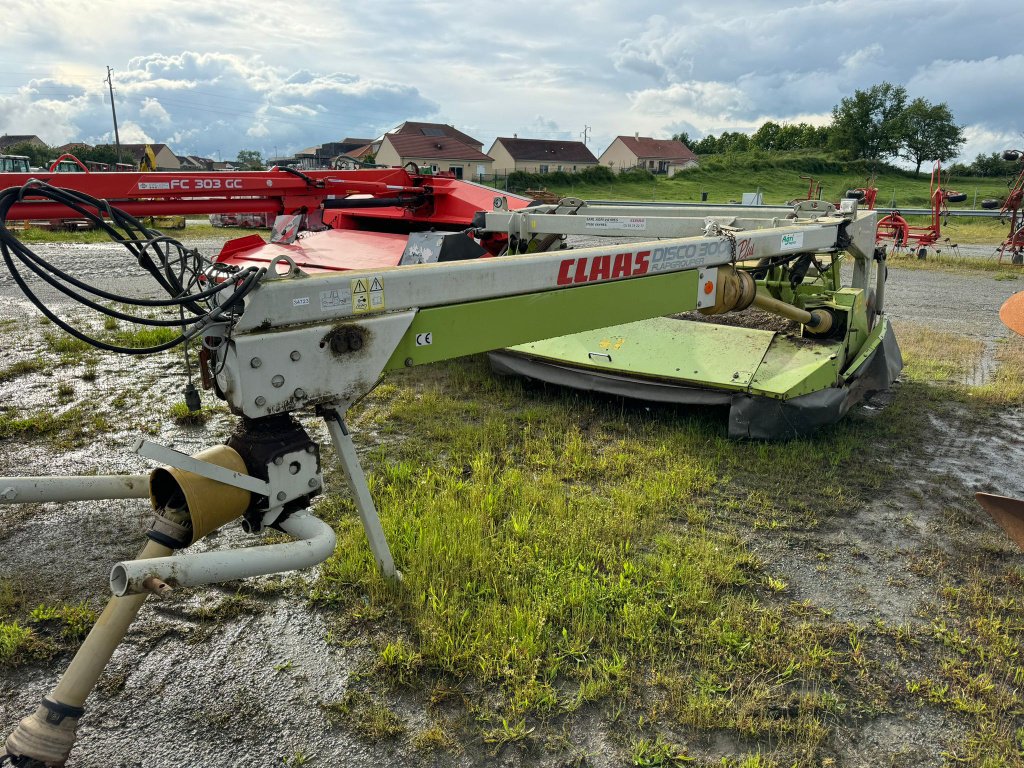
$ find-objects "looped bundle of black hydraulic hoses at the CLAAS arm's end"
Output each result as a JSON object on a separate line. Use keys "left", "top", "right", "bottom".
{"left": 0, "top": 179, "right": 266, "bottom": 354}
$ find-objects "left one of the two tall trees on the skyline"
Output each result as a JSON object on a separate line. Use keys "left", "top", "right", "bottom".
{"left": 829, "top": 83, "right": 906, "bottom": 160}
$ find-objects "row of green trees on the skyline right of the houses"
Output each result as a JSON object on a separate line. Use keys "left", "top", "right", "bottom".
{"left": 674, "top": 83, "right": 966, "bottom": 172}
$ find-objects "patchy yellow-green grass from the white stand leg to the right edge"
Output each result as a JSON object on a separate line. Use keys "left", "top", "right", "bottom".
{"left": 308, "top": 328, "right": 1024, "bottom": 766}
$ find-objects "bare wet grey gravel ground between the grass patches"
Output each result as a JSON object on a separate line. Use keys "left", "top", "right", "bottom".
{"left": 0, "top": 231, "right": 1024, "bottom": 768}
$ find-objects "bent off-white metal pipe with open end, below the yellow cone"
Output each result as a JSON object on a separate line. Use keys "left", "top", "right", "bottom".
{"left": 111, "top": 511, "right": 336, "bottom": 596}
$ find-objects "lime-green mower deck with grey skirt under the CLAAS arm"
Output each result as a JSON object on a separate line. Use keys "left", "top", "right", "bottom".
{"left": 490, "top": 316, "right": 902, "bottom": 439}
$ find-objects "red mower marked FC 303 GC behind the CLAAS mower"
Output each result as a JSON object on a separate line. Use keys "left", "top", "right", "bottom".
{"left": 0, "top": 167, "right": 532, "bottom": 271}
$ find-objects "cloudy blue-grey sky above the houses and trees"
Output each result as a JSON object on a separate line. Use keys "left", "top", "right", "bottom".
{"left": 0, "top": 0, "right": 1024, "bottom": 160}
